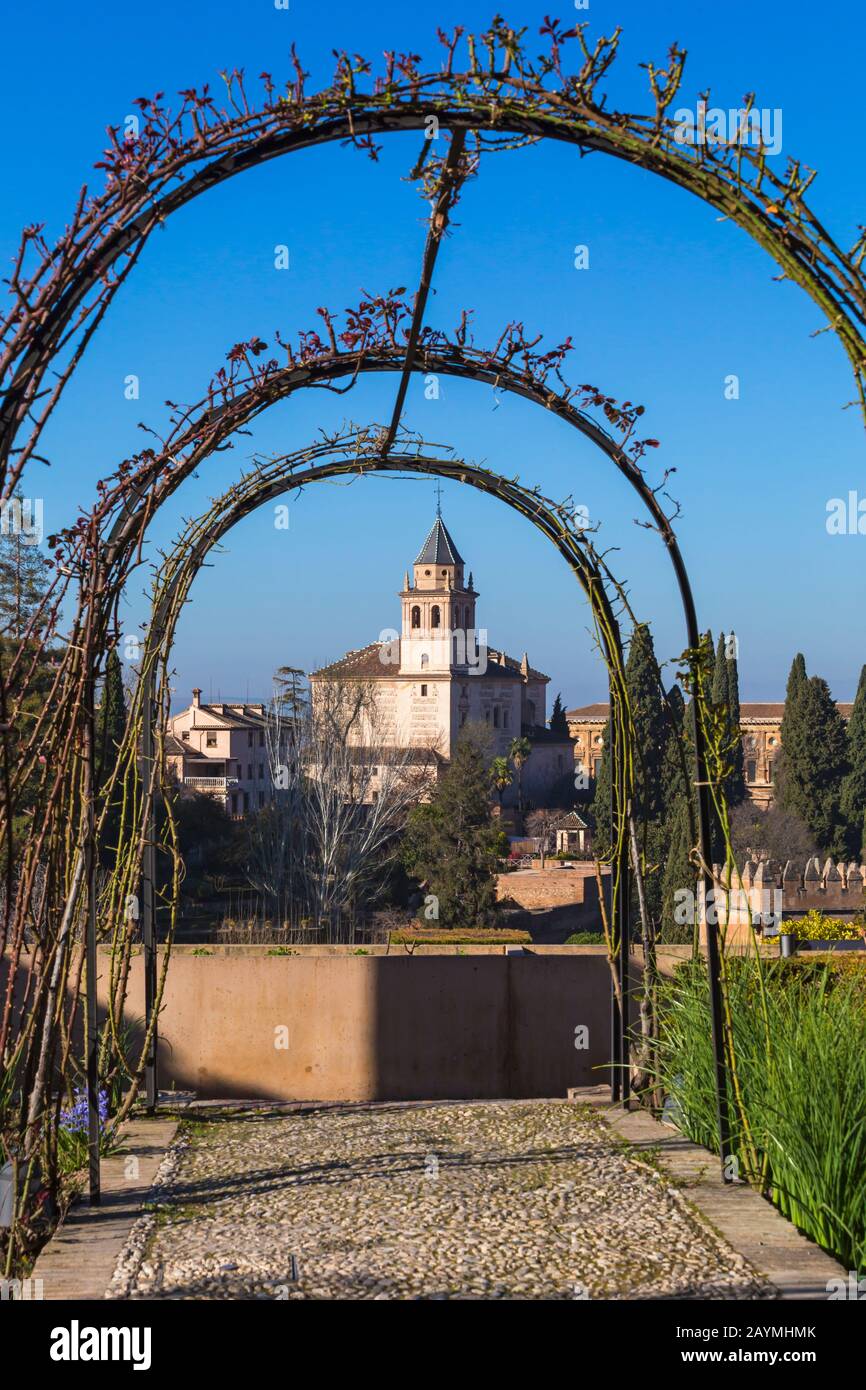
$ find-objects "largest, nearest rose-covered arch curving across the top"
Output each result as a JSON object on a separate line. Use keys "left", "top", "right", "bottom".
{"left": 0, "top": 18, "right": 866, "bottom": 496}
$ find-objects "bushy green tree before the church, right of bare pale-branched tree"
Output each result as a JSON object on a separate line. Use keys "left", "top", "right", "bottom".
{"left": 403, "top": 724, "right": 500, "bottom": 929}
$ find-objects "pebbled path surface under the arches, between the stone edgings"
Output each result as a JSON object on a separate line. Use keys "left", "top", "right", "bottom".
{"left": 107, "top": 1101, "right": 771, "bottom": 1300}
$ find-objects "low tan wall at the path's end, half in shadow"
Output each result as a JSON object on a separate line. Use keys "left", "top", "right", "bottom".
{"left": 100, "top": 947, "right": 625, "bottom": 1101}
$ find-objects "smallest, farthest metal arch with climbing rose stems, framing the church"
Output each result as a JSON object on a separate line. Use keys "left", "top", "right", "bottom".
{"left": 10, "top": 421, "right": 650, "bottom": 1194}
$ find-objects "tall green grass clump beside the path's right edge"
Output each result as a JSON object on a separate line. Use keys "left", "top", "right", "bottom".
{"left": 659, "top": 959, "right": 866, "bottom": 1270}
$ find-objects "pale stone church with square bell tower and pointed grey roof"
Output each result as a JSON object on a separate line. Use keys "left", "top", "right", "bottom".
{"left": 310, "top": 516, "right": 574, "bottom": 806}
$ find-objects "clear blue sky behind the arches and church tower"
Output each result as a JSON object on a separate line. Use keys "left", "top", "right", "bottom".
{"left": 0, "top": 0, "right": 866, "bottom": 705}
